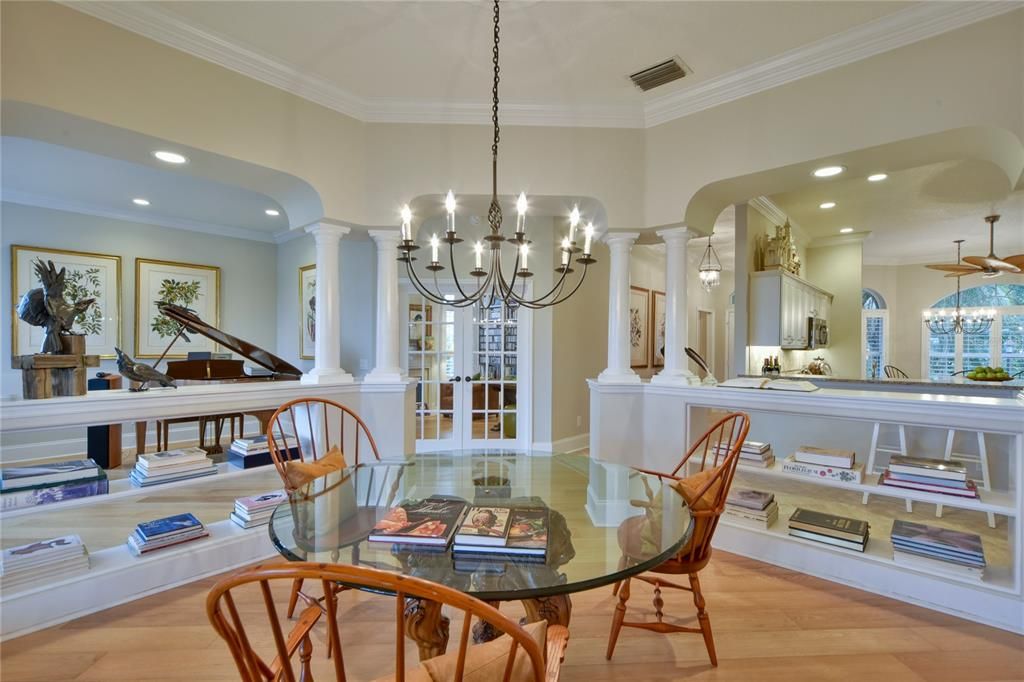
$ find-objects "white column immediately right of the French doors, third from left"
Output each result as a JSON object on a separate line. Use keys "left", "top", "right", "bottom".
{"left": 597, "top": 232, "right": 640, "bottom": 384}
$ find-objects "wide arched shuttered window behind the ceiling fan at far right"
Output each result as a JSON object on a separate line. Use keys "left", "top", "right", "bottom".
{"left": 923, "top": 284, "right": 1024, "bottom": 379}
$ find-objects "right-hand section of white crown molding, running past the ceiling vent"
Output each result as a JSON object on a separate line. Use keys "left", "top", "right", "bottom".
{"left": 644, "top": 0, "right": 1024, "bottom": 128}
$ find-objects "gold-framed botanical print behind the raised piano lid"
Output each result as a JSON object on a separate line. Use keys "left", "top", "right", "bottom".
{"left": 135, "top": 258, "right": 220, "bottom": 357}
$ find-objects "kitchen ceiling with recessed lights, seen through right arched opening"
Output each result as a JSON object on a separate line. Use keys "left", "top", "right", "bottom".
{"left": 770, "top": 161, "right": 1024, "bottom": 264}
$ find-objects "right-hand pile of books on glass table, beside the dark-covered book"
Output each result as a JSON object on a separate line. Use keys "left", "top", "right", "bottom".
{"left": 452, "top": 499, "right": 548, "bottom": 560}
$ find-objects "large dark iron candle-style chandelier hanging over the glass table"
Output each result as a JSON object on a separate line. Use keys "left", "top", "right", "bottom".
{"left": 398, "top": 0, "right": 597, "bottom": 309}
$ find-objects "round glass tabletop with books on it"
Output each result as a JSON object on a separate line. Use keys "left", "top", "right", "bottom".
{"left": 269, "top": 451, "right": 692, "bottom": 602}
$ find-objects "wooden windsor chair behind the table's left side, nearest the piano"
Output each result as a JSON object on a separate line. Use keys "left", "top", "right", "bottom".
{"left": 266, "top": 397, "right": 381, "bottom": 617}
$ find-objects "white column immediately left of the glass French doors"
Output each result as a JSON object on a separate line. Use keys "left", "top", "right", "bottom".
{"left": 366, "top": 229, "right": 402, "bottom": 376}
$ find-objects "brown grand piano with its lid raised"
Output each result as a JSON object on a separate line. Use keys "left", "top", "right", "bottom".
{"left": 135, "top": 303, "right": 302, "bottom": 455}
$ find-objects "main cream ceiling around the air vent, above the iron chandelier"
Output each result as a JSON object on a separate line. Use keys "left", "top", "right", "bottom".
{"left": 68, "top": 0, "right": 1016, "bottom": 127}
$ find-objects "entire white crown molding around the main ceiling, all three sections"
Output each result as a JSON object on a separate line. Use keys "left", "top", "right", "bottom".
{"left": 62, "top": 0, "right": 1024, "bottom": 128}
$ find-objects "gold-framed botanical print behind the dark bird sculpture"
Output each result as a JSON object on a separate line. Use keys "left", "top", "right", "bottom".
{"left": 10, "top": 246, "right": 121, "bottom": 357}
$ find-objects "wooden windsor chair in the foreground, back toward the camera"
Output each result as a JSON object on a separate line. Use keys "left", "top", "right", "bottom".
{"left": 206, "top": 562, "right": 568, "bottom": 682}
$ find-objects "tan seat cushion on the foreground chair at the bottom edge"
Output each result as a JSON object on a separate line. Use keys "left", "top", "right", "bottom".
{"left": 374, "top": 621, "right": 548, "bottom": 682}
